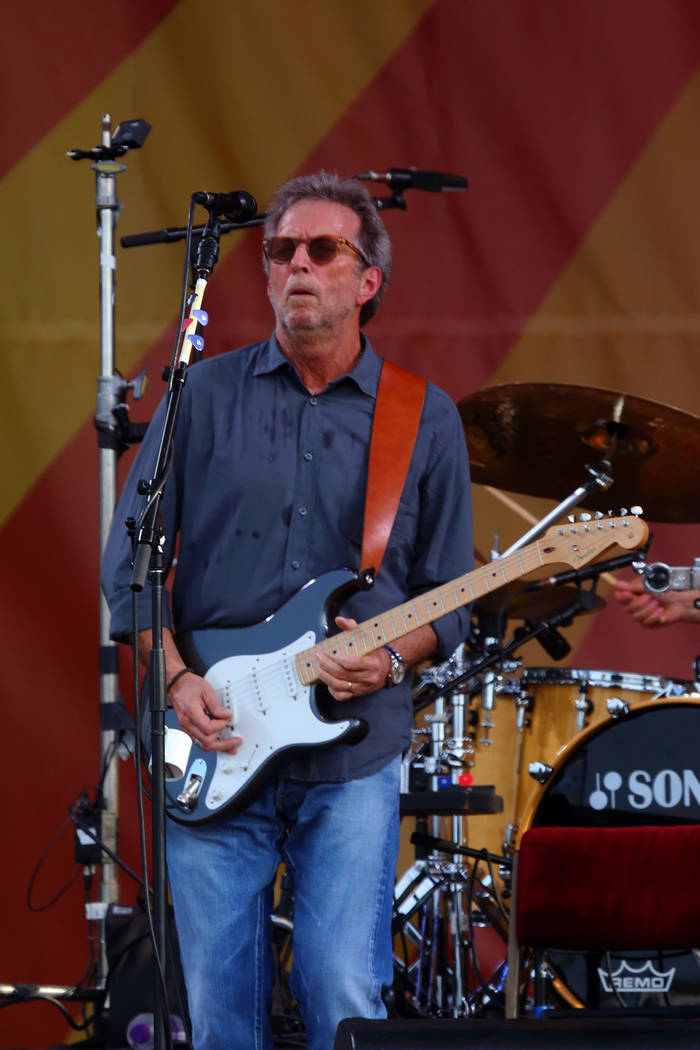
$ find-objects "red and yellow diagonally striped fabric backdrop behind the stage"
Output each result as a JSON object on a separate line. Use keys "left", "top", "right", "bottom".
{"left": 0, "top": 6, "right": 700, "bottom": 1047}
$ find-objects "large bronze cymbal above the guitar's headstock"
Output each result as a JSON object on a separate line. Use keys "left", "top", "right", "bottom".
{"left": 458, "top": 383, "right": 700, "bottom": 522}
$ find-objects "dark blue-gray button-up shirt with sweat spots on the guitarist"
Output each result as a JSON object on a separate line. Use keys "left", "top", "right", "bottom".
{"left": 103, "top": 336, "right": 473, "bottom": 780}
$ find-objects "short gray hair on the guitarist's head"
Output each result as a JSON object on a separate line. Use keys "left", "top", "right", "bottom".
{"left": 262, "top": 171, "right": 391, "bottom": 328}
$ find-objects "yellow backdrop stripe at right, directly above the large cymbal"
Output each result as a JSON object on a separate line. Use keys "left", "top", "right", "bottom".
{"left": 492, "top": 63, "right": 700, "bottom": 417}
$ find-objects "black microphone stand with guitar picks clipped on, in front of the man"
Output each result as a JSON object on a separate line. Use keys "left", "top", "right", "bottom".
{"left": 130, "top": 206, "right": 220, "bottom": 1050}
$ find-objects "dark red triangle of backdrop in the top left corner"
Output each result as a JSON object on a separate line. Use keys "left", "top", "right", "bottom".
{"left": 0, "top": 0, "right": 177, "bottom": 177}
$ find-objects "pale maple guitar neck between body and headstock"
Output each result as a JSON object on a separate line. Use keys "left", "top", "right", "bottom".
{"left": 296, "top": 542, "right": 545, "bottom": 686}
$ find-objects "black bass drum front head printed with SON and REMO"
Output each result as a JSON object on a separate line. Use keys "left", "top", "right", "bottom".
{"left": 518, "top": 694, "right": 700, "bottom": 1007}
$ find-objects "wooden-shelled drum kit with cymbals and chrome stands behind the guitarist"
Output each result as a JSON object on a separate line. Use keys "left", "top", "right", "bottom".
{"left": 394, "top": 383, "right": 700, "bottom": 1017}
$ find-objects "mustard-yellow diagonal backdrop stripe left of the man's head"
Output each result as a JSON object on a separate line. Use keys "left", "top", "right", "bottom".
{"left": 0, "top": 0, "right": 433, "bottom": 521}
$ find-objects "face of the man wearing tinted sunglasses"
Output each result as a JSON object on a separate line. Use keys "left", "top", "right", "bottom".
{"left": 268, "top": 201, "right": 381, "bottom": 338}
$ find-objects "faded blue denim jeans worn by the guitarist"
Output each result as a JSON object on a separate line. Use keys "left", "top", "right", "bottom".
{"left": 167, "top": 757, "right": 401, "bottom": 1050}
